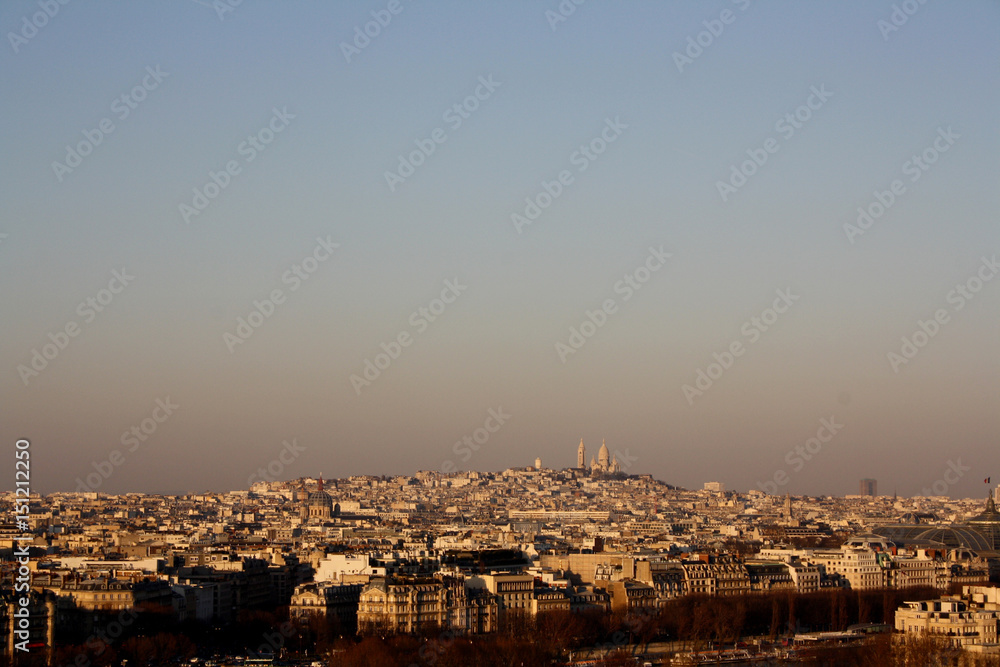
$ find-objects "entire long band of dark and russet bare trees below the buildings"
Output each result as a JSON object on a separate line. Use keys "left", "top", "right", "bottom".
{"left": 24, "top": 588, "right": 984, "bottom": 667}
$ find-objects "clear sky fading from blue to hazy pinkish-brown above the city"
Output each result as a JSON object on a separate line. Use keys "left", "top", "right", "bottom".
{"left": 0, "top": 0, "right": 1000, "bottom": 497}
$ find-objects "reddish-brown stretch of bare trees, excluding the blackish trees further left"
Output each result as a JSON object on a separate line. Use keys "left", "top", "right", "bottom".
{"left": 334, "top": 588, "right": 944, "bottom": 667}
